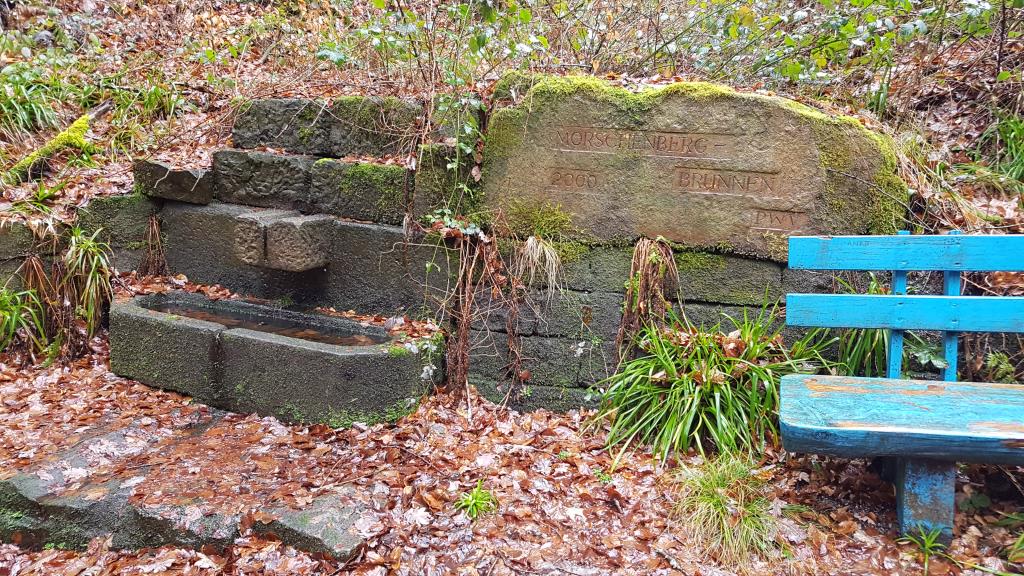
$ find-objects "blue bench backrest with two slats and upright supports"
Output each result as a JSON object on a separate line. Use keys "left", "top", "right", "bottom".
{"left": 785, "top": 232, "right": 1024, "bottom": 381}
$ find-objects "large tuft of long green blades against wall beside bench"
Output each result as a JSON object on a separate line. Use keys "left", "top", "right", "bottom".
{"left": 598, "top": 305, "right": 831, "bottom": 459}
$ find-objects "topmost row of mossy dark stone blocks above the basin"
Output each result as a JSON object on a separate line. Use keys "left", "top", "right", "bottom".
{"left": 232, "top": 96, "right": 423, "bottom": 158}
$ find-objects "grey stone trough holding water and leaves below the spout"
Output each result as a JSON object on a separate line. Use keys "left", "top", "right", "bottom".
{"left": 110, "top": 292, "right": 429, "bottom": 426}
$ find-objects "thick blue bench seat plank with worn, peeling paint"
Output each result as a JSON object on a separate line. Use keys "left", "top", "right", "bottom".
{"left": 779, "top": 375, "right": 1024, "bottom": 464}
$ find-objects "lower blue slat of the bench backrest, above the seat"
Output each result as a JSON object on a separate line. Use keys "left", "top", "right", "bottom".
{"left": 785, "top": 294, "right": 1024, "bottom": 332}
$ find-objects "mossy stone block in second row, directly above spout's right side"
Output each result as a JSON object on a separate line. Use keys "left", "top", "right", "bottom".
{"left": 310, "top": 158, "right": 409, "bottom": 225}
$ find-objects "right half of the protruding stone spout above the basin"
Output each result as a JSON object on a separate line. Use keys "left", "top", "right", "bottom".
{"left": 266, "top": 214, "right": 334, "bottom": 272}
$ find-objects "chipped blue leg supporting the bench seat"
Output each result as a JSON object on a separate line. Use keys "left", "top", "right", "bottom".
{"left": 896, "top": 458, "right": 956, "bottom": 544}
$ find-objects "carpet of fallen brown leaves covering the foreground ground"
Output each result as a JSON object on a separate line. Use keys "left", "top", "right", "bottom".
{"left": 0, "top": 338, "right": 1021, "bottom": 575}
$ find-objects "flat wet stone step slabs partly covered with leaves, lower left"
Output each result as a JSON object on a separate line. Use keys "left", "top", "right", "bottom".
{"left": 0, "top": 410, "right": 362, "bottom": 559}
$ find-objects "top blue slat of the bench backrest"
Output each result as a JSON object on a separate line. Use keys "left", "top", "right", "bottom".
{"left": 790, "top": 235, "right": 1024, "bottom": 272}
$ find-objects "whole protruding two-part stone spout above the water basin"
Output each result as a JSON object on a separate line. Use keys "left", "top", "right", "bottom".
{"left": 234, "top": 210, "right": 334, "bottom": 272}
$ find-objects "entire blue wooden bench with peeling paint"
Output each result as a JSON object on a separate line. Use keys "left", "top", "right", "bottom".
{"left": 779, "top": 229, "right": 1024, "bottom": 540}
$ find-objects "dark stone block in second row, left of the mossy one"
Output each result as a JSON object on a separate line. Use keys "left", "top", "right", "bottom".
{"left": 213, "top": 150, "right": 315, "bottom": 210}
